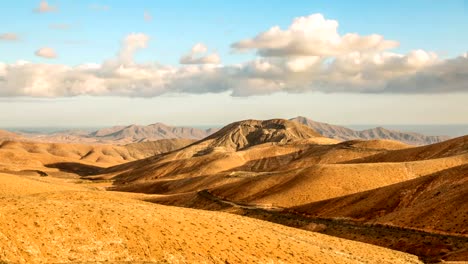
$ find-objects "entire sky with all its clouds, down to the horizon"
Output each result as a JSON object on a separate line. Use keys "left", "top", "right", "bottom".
{"left": 0, "top": 0, "right": 468, "bottom": 127}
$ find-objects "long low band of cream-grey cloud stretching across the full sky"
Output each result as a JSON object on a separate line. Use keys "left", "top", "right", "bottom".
{"left": 0, "top": 14, "right": 468, "bottom": 97}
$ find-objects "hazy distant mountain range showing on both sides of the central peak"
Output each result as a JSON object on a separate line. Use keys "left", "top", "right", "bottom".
{"left": 0, "top": 116, "right": 450, "bottom": 145}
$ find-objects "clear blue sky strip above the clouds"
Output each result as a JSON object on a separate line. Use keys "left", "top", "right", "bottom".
{"left": 0, "top": 0, "right": 468, "bottom": 65}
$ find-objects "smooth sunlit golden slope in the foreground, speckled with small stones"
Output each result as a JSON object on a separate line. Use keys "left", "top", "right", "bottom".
{"left": 0, "top": 174, "right": 421, "bottom": 264}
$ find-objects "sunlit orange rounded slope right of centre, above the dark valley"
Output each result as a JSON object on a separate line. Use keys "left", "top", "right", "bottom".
{"left": 211, "top": 156, "right": 468, "bottom": 207}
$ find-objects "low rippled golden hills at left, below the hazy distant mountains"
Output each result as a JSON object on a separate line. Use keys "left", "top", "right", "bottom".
{"left": 0, "top": 139, "right": 193, "bottom": 171}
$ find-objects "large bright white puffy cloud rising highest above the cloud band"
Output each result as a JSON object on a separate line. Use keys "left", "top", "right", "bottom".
{"left": 232, "top": 14, "right": 398, "bottom": 57}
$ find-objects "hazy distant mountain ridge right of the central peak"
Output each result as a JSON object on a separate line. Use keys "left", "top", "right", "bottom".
{"left": 290, "top": 116, "right": 450, "bottom": 145}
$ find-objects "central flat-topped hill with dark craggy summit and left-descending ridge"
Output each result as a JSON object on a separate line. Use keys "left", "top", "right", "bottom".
{"left": 100, "top": 120, "right": 328, "bottom": 182}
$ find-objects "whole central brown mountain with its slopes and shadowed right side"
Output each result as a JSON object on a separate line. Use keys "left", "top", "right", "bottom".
{"left": 98, "top": 126, "right": 468, "bottom": 263}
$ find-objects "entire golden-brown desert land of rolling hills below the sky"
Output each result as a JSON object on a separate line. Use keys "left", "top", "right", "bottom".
{"left": 0, "top": 119, "right": 468, "bottom": 263}
